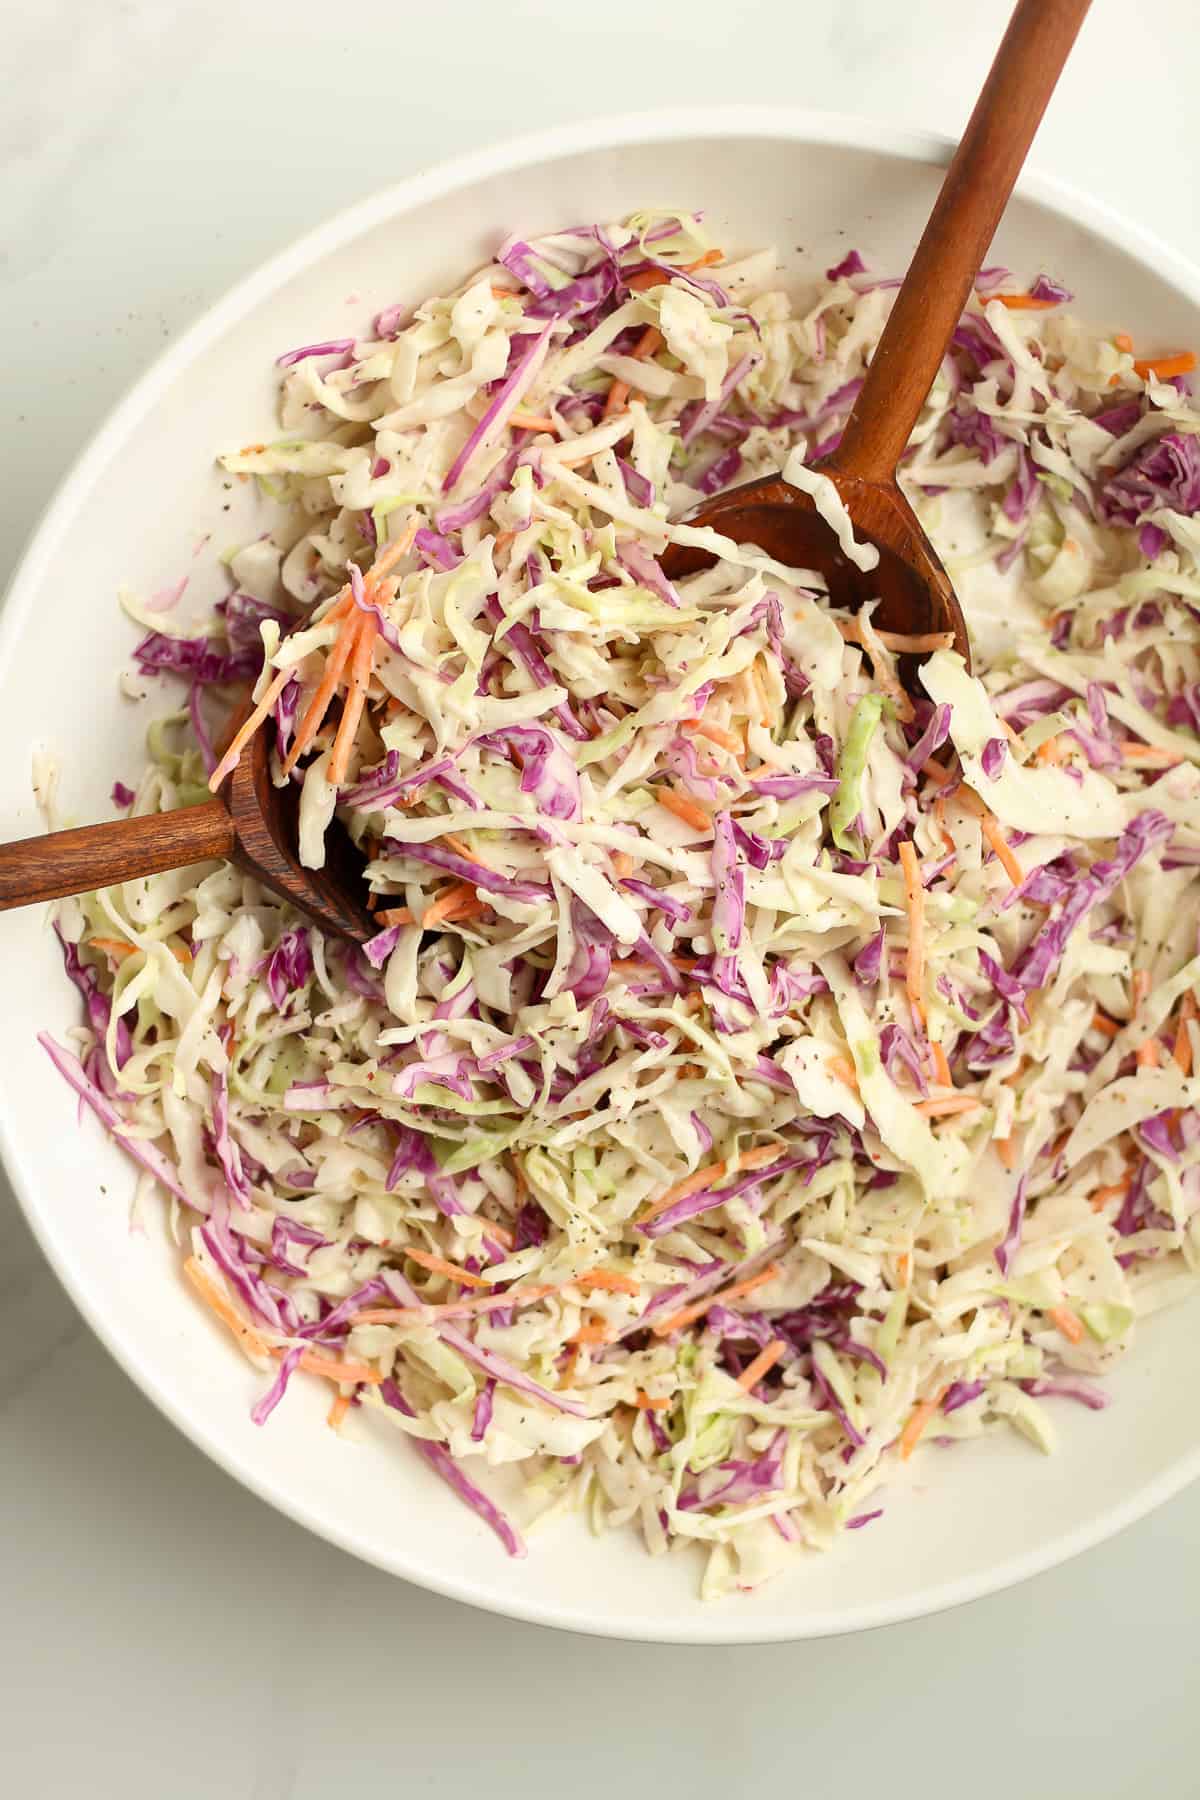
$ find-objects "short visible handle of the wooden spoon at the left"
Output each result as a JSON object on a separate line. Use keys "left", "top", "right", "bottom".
{"left": 0, "top": 799, "right": 237, "bottom": 913}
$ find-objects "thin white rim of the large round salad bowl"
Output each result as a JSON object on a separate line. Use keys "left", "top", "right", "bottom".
{"left": 9, "top": 104, "right": 1200, "bottom": 1645}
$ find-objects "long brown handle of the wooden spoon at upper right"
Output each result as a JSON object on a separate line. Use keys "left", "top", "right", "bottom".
{"left": 826, "top": 0, "right": 1090, "bottom": 482}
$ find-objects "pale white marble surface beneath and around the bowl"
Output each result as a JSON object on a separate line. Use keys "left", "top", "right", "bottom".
{"left": 0, "top": 0, "right": 1200, "bottom": 1800}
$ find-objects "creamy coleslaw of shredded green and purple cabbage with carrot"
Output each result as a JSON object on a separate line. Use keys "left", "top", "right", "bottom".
{"left": 43, "top": 212, "right": 1200, "bottom": 1595}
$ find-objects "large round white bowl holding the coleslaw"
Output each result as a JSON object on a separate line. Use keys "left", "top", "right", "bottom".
{"left": 0, "top": 108, "right": 1200, "bottom": 1643}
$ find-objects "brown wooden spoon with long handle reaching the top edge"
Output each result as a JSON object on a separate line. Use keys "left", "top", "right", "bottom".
{"left": 660, "top": 0, "right": 1090, "bottom": 669}
